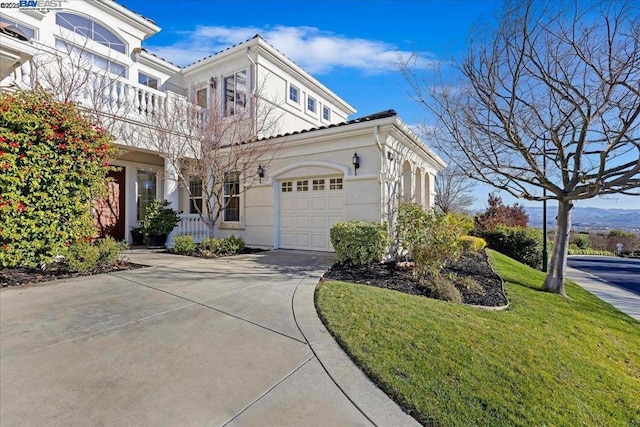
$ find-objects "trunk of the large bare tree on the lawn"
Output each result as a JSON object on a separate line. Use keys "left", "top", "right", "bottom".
{"left": 542, "top": 201, "right": 573, "bottom": 297}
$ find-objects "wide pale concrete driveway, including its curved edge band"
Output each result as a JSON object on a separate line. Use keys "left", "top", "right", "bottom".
{"left": 0, "top": 251, "right": 415, "bottom": 427}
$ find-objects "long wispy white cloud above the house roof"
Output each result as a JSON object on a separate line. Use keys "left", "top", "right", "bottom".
{"left": 148, "top": 26, "right": 438, "bottom": 74}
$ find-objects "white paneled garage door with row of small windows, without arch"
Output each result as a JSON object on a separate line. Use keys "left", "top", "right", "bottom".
{"left": 279, "top": 177, "right": 344, "bottom": 251}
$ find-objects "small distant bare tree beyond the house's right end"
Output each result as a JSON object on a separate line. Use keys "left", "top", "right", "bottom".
{"left": 434, "top": 164, "right": 476, "bottom": 213}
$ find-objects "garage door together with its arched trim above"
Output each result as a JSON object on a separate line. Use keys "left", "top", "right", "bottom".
{"left": 271, "top": 161, "right": 349, "bottom": 251}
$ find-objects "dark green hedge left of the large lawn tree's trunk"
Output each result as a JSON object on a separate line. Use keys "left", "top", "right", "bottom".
{"left": 475, "top": 227, "right": 542, "bottom": 270}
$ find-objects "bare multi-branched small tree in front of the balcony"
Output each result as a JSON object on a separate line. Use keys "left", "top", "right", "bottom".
{"left": 143, "top": 78, "right": 281, "bottom": 237}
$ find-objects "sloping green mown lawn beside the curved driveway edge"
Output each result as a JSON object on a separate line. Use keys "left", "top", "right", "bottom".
{"left": 316, "top": 251, "right": 640, "bottom": 426}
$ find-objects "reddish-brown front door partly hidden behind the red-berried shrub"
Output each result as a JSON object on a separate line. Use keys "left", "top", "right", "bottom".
{"left": 94, "top": 168, "right": 125, "bottom": 240}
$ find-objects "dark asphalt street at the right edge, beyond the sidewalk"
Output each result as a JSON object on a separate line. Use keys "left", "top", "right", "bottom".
{"left": 567, "top": 256, "right": 640, "bottom": 295}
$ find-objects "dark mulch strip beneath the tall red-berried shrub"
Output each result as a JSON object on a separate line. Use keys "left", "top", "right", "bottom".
{"left": 0, "top": 261, "right": 146, "bottom": 288}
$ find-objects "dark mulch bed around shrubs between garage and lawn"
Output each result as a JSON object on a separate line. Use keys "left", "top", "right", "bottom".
{"left": 324, "top": 252, "right": 508, "bottom": 307}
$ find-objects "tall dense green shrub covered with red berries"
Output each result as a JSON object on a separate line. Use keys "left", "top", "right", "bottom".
{"left": 0, "top": 91, "right": 116, "bottom": 267}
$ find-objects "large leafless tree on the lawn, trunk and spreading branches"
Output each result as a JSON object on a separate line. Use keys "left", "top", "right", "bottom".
{"left": 402, "top": 0, "right": 640, "bottom": 295}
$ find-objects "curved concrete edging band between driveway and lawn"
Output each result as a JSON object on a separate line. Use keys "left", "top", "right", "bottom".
{"left": 293, "top": 270, "right": 420, "bottom": 427}
